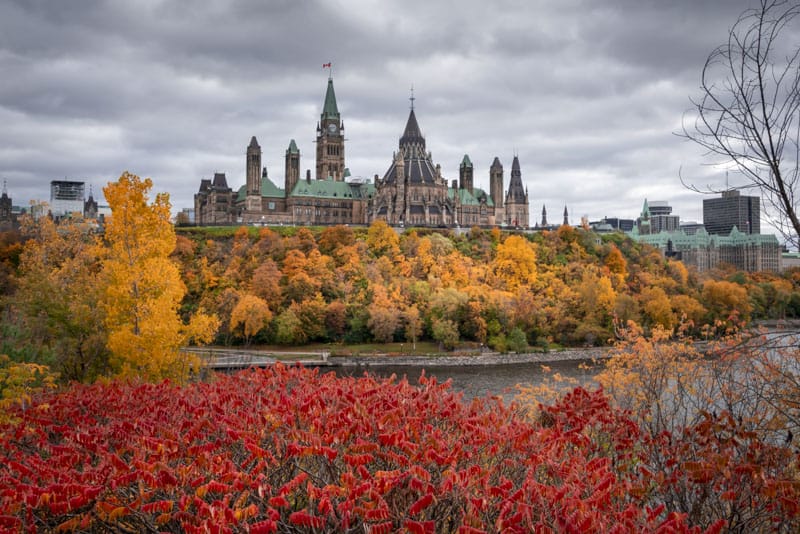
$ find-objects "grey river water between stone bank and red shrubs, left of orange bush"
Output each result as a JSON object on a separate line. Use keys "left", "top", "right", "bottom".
{"left": 334, "top": 360, "right": 603, "bottom": 403}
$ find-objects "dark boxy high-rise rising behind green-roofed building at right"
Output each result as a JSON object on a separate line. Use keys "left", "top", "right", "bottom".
{"left": 703, "top": 189, "right": 761, "bottom": 235}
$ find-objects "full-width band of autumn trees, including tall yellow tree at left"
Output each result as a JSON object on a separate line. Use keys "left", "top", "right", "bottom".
{"left": 0, "top": 197, "right": 800, "bottom": 381}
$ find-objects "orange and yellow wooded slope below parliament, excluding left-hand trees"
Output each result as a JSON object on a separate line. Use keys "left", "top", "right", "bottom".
{"left": 173, "top": 222, "right": 800, "bottom": 351}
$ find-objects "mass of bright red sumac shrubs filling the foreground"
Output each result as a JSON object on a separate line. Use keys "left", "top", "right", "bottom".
{"left": 0, "top": 365, "right": 798, "bottom": 533}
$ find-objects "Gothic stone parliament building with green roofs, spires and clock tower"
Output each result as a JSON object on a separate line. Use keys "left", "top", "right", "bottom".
{"left": 194, "top": 78, "right": 529, "bottom": 228}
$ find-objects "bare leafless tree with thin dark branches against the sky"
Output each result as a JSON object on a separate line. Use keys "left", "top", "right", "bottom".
{"left": 682, "top": 0, "right": 800, "bottom": 246}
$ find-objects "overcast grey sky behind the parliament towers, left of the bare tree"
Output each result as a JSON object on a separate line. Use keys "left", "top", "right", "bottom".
{"left": 0, "top": 0, "right": 780, "bottom": 228}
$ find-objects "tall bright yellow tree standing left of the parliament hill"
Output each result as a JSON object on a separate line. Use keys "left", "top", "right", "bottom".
{"left": 102, "top": 172, "right": 218, "bottom": 381}
